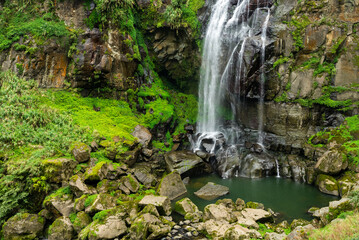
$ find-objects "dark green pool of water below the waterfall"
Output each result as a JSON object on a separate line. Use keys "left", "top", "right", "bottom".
{"left": 186, "top": 174, "right": 338, "bottom": 221}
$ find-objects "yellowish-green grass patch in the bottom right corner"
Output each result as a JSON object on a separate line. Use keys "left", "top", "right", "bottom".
{"left": 309, "top": 213, "right": 359, "bottom": 240}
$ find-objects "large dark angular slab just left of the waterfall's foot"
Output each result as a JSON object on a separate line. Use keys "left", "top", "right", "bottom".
{"left": 164, "top": 150, "right": 205, "bottom": 175}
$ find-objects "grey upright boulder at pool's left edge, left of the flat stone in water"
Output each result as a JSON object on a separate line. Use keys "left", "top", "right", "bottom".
{"left": 158, "top": 172, "right": 187, "bottom": 200}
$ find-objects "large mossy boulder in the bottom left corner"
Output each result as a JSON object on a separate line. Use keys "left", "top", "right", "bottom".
{"left": 2, "top": 213, "right": 45, "bottom": 240}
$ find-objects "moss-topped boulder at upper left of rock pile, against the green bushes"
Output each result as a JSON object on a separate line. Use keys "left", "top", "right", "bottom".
{"left": 42, "top": 158, "right": 77, "bottom": 183}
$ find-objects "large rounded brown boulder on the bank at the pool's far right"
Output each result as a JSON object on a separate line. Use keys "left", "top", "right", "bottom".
{"left": 315, "top": 150, "right": 348, "bottom": 175}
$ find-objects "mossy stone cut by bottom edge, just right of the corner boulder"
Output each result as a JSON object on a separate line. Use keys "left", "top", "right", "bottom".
{"left": 48, "top": 217, "right": 74, "bottom": 240}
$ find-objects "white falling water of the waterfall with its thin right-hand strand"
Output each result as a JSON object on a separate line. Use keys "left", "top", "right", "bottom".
{"left": 194, "top": 0, "right": 270, "bottom": 153}
